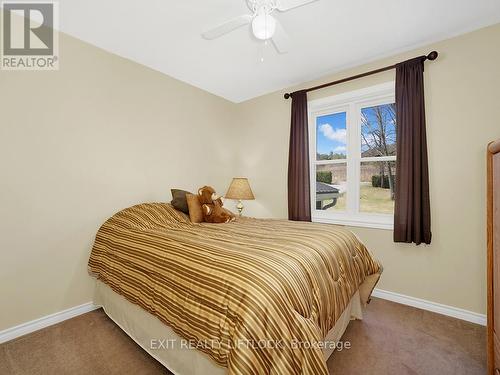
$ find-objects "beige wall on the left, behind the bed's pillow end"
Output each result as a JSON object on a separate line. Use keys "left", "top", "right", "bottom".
{"left": 0, "top": 35, "right": 234, "bottom": 330}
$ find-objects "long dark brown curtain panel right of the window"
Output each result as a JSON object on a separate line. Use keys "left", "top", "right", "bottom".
{"left": 394, "top": 57, "right": 431, "bottom": 245}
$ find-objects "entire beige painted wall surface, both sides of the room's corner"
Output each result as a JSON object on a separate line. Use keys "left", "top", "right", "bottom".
{"left": 0, "top": 20, "right": 500, "bottom": 330}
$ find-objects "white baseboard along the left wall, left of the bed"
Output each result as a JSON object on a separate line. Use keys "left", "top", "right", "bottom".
{"left": 0, "top": 302, "right": 98, "bottom": 344}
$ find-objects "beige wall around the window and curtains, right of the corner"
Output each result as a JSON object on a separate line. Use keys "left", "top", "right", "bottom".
{"left": 232, "top": 25, "right": 500, "bottom": 313}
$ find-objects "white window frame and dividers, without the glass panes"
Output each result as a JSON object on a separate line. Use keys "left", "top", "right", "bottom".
{"left": 308, "top": 81, "right": 396, "bottom": 230}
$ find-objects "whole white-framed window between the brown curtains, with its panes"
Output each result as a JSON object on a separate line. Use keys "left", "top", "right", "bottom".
{"left": 308, "top": 82, "right": 397, "bottom": 229}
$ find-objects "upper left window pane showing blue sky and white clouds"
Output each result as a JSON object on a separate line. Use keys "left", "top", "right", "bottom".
{"left": 316, "top": 112, "right": 347, "bottom": 160}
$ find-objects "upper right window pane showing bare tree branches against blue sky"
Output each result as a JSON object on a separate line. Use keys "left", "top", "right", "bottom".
{"left": 361, "top": 104, "right": 396, "bottom": 158}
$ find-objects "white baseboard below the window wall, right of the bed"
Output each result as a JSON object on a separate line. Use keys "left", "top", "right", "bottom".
{"left": 372, "top": 289, "right": 486, "bottom": 326}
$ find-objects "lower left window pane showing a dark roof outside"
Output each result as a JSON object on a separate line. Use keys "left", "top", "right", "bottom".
{"left": 316, "top": 163, "right": 347, "bottom": 212}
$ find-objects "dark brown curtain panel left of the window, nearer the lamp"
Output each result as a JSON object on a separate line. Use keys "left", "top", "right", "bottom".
{"left": 288, "top": 91, "right": 311, "bottom": 221}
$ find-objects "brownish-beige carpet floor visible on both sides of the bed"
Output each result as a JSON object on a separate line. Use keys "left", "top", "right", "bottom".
{"left": 0, "top": 298, "right": 486, "bottom": 375}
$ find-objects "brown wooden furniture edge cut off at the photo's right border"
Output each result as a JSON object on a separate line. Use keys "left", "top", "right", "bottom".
{"left": 486, "top": 140, "right": 500, "bottom": 375}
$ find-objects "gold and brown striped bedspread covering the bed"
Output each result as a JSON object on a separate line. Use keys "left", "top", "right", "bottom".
{"left": 89, "top": 203, "right": 381, "bottom": 375}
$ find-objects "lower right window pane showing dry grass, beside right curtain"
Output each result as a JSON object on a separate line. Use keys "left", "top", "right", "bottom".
{"left": 359, "top": 161, "right": 396, "bottom": 214}
